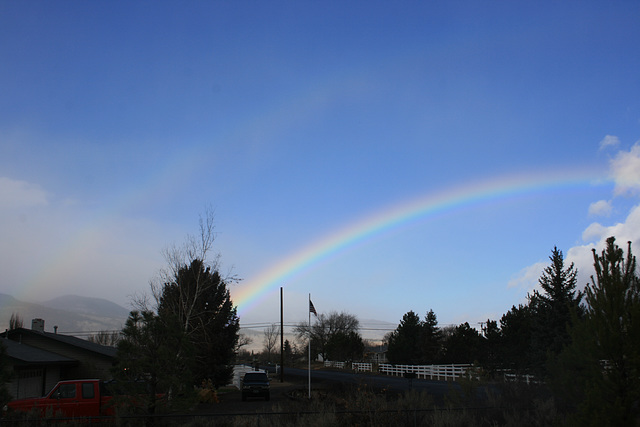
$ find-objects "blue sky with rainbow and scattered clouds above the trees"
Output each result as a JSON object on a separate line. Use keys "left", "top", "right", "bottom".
{"left": 0, "top": 0, "right": 640, "bottom": 340}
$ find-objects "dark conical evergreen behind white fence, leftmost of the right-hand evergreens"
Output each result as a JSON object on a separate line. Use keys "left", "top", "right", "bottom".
{"left": 387, "top": 311, "right": 424, "bottom": 365}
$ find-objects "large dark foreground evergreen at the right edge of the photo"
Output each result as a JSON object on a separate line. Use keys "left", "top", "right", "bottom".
{"left": 552, "top": 237, "right": 640, "bottom": 426}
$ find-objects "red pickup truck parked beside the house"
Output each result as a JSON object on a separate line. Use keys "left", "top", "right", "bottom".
{"left": 7, "top": 380, "right": 114, "bottom": 418}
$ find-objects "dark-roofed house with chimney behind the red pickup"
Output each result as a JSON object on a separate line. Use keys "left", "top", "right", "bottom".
{"left": 0, "top": 319, "right": 116, "bottom": 398}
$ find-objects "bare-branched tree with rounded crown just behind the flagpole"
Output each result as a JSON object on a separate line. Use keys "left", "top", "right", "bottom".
{"left": 294, "top": 311, "right": 360, "bottom": 360}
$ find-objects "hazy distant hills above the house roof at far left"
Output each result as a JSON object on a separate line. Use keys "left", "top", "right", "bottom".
{"left": 0, "top": 294, "right": 129, "bottom": 337}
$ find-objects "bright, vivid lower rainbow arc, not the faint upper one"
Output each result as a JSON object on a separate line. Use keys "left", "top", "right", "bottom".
{"left": 233, "top": 168, "right": 606, "bottom": 314}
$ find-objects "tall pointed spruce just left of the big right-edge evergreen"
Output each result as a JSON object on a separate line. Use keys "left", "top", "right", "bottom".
{"left": 529, "top": 247, "right": 583, "bottom": 374}
